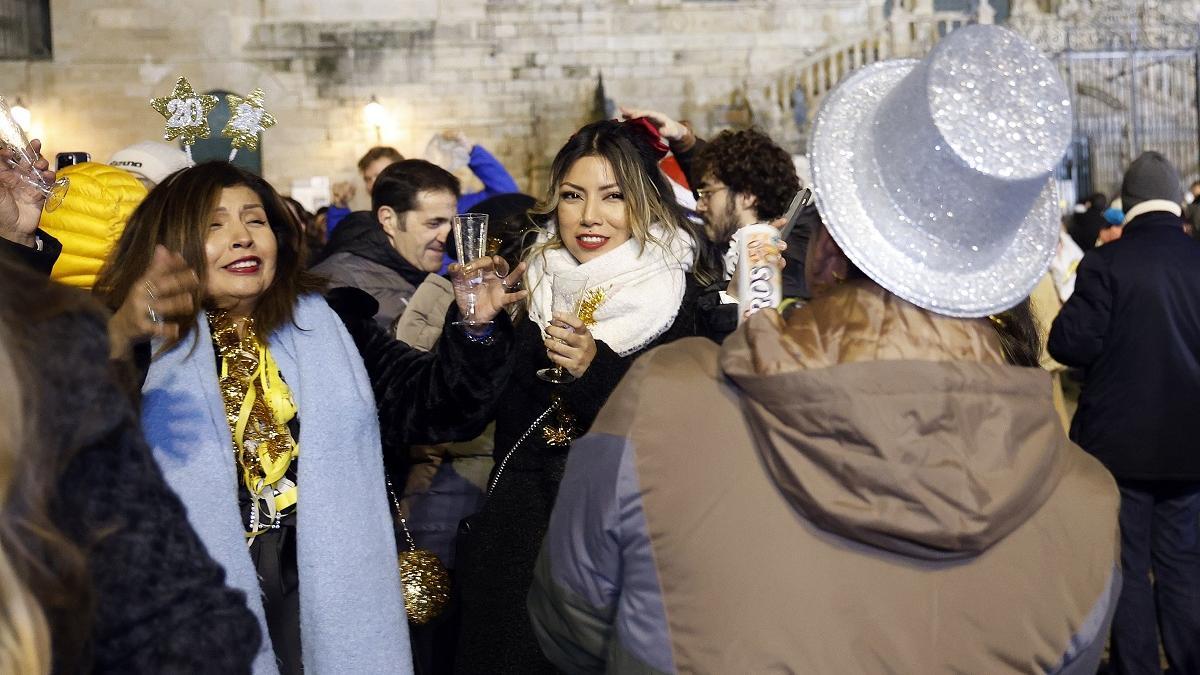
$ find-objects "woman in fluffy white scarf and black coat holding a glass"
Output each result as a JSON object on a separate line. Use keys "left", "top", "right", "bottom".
{"left": 456, "top": 120, "right": 719, "bottom": 674}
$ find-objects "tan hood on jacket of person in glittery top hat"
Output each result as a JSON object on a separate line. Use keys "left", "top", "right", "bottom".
{"left": 721, "top": 281, "right": 1069, "bottom": 560}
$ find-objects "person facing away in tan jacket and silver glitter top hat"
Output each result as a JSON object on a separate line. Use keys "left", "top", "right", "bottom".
{"left": 528, "top": 26, "right": 1121, "bottom": 675}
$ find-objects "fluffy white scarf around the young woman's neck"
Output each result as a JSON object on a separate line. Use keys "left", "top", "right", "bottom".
{"left": 526, "top": 222, "right": 696, "bottom": 357}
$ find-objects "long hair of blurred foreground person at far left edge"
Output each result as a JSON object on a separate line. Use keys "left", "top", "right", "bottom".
{"left": 0, "top": 256, "right": 96, "bottom": 673}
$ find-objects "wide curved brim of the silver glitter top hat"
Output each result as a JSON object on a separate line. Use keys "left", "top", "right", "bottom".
{"left": 809, "top": 59, "right": 1058, "bottom": 318}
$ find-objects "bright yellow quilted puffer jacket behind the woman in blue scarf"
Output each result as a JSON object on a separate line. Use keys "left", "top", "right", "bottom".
{"left": 42, "top": 162, "right": 146, "bottom": 288}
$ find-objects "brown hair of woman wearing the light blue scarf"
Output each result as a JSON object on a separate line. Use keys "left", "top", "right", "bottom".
{"left": 96, "top": 162, "right": 322, "bottom": 350}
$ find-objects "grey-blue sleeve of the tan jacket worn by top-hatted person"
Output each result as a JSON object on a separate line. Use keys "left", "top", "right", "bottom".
{"left": 529, "top": 434, "right": 674, "bottom": 673}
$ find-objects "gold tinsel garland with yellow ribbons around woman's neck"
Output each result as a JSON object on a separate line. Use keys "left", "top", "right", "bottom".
{"left": 209, "top": 311, "right": 300, "bottom": 543}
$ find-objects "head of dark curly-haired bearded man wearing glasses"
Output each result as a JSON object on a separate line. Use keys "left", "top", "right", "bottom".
{"left": 694, "top": 129, "right": 800, "bottom": 245}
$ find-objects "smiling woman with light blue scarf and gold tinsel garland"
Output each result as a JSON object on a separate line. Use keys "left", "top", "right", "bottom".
{"left": 98, "top": 162, "right": 521, "bottom": 675}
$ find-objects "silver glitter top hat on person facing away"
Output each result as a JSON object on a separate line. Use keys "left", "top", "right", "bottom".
{"left": 810, "top": 25, "right": 1072, "bottom": 317}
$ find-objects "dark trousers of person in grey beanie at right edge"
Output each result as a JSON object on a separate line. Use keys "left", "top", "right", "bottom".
{"left": 1110, "top": 480, "right": 1200, "bottom": 675}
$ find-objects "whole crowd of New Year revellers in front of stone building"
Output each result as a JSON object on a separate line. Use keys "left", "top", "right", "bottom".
{"left": 0, "top": 25, "right": 1200, "bottom": 675}
